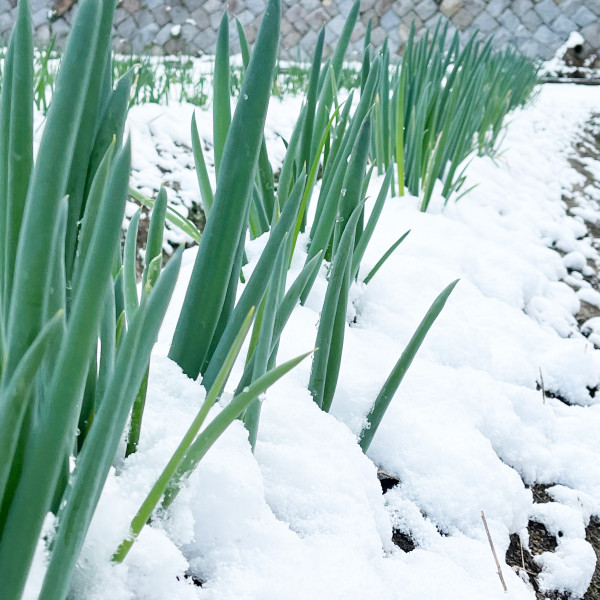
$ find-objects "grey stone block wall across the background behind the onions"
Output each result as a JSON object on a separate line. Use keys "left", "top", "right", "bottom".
{"left": 0, "top": 0, "right": 600, "bottom": 59}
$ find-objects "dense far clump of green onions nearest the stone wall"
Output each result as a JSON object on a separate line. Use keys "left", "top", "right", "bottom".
{"left": 363, "top": 21, "right": 538, "bottom": 210}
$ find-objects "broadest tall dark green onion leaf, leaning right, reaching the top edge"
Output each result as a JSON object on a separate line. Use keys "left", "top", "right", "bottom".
{"left": 169, "top": 0, "right": 281, "bottom": 378}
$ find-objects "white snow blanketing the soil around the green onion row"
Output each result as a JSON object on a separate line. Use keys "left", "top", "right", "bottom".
{"left": 29, "top": 85, "right": 600, "bottom": 600}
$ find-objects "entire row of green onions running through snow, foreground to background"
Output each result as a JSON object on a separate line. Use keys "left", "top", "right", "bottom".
{"left": 0, "top": 0, "right": 540, "bottom": 600}
